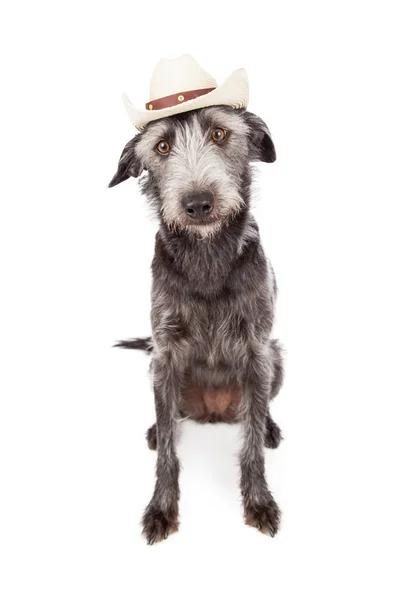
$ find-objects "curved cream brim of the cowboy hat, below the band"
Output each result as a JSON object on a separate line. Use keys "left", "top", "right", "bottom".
{"left": 122, "top": 69, "right": 249, "bottom": 129}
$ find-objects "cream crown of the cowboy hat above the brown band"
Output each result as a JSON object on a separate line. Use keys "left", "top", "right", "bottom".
{"left": 149, "top": 54, "right": 217, "bottom": 101}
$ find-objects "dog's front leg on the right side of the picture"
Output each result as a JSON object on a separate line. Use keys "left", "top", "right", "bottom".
{"left": 240, "top": 355, "right": 280, "bottom": 536}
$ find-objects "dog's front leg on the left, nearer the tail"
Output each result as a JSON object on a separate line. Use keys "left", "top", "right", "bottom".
{"left": 142, "top": 357, "right": 183, "bottom": 544}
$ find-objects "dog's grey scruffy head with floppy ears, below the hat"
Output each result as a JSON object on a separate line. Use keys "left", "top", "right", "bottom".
{"left": 110, "top": 106, "right": 275, "bottom": 237}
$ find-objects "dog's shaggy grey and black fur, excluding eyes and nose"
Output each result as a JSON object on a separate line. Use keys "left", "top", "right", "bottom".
{"left": 110, "top": 106, "right": 283, "bottom": 544}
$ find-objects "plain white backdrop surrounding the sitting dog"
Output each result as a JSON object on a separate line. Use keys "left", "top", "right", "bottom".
{"left": 0, "top": 0, "right": 400, "bottom": 600}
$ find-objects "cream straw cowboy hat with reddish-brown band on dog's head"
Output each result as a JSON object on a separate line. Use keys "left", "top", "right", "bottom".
{"left": 122, "top": 54, "right": 249, "bottom": 129}
